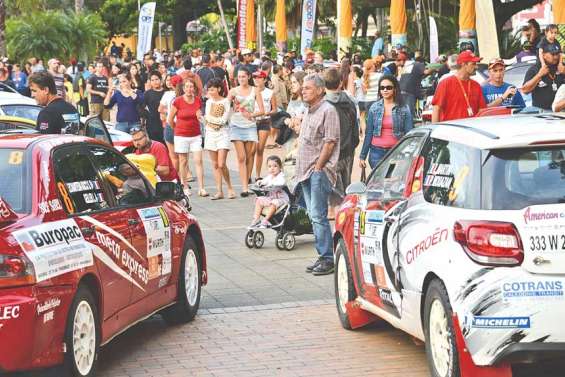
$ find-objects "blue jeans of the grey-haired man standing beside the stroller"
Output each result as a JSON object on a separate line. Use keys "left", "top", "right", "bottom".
{"left": 300, "top": 172, "right": 333, "bottom": 261}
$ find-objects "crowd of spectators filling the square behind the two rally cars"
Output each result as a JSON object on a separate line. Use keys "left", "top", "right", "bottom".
{"left": 0, "top": 19, "right": 565, "bottom": 275}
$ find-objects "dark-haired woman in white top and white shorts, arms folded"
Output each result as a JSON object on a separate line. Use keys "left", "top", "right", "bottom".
{"left": 204, "top": 78, "right": 235, "bottom": 200}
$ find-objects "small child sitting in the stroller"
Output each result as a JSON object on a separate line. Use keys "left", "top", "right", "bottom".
{"left": 250, "top": 156, "right": 288, "bottom": 228}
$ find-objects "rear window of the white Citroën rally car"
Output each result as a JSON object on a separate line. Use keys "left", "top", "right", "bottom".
{"left": 482, "top": 147, "right": 565, "bottom": 210}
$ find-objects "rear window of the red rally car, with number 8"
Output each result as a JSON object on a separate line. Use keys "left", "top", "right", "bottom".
{"left": 0, "top": 148, "right": 31, "bottom": 213}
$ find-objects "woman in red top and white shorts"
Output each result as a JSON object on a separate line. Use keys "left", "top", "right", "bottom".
{"left": 169, "top": 78, "right": 208, "bottom": 196}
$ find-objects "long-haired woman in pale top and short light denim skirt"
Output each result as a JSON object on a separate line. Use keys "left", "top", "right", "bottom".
{"left": 228, "top": 67, "right": 264, "bottom": 198}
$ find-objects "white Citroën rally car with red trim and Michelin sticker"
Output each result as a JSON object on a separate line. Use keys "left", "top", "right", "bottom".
{"left": 334, "top": 114, "right": 565, "bottom": 377}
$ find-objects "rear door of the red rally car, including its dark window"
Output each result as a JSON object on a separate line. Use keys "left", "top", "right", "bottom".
{"left": 52, "top": 146, "right": 134, "bottom": 319}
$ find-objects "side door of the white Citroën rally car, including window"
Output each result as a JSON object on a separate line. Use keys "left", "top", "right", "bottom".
{"left": 355, "top": 135, "right": 424, "bottom": 317}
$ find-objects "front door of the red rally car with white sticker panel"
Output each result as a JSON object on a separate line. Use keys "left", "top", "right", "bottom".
{"left": 83, "top": 146, "right": 167, "bottom": 302}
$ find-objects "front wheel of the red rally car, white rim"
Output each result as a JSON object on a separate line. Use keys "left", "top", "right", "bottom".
{"left": 162, "top": 236, "right": 202, "bottom": 325}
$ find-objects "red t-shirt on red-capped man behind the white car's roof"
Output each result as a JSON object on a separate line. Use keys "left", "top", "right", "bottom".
{"left": 432, "top": 75, "right": 487, "bottom": 122}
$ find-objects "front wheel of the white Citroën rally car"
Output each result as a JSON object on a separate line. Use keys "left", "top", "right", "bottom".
{"left": 334, "top": 238, "right": 357, "bottom": 330}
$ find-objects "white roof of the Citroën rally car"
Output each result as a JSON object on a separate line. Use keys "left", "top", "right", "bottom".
{"left": 429, "top": 113, "right": 565, "bottom": 149}
